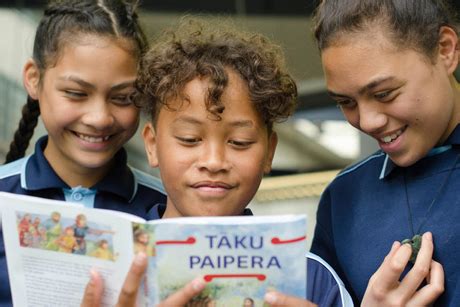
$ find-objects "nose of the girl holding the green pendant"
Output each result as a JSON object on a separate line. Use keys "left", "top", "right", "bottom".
{"left": 359, "top": 102, "right": 388, "bottom": 134}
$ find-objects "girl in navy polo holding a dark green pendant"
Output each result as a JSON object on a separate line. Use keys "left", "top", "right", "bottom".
{"left": 312, "top": 0, "right": 460, "bottom": 306}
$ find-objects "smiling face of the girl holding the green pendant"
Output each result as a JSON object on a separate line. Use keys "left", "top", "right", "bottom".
{"left": 322, "top": 28, "right": 460, "bottom": 166}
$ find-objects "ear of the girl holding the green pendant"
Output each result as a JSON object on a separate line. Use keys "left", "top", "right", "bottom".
{"left": 438, "top": 27, "right": 460, "bottom": 74}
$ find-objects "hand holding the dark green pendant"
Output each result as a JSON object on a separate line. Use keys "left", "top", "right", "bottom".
{"left": 362, "top": 232, "right": 444, "bottom": 306}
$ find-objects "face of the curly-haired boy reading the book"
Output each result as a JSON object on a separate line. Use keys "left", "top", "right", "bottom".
{"left": 143, "top": 71, "right": 276, "bottom": 217}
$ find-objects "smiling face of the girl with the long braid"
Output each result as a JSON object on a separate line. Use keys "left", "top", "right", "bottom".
{"left": 24, "top": 35, "right": 139, "bottom": 184}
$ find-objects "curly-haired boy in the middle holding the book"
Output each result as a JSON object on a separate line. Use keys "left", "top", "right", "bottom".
{"left": 84, "top": 20, "right": 348, "bottom": 306}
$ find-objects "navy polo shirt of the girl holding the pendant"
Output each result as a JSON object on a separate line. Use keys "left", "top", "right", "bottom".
{"left": 311, "top": 126, "right": 460, "bottom": 306}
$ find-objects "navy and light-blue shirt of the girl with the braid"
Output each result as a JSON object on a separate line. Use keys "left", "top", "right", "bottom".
{"left": 0, "top": 136, "right": 166, "bottom": 306}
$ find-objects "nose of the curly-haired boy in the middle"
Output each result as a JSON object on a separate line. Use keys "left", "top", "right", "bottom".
{"left": 198, "top": 144, "right": 230, "bottom": 173}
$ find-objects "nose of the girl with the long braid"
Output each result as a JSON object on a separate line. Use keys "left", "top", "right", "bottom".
{"left": 82, "top": 98, "right": 115, "bottom": 130}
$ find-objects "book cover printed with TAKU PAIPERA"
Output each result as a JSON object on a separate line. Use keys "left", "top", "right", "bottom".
{"left": 147, "top": 215, "right": 307, "bottom": 306}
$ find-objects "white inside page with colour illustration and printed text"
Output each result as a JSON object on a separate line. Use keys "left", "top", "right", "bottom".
{"left": 0, "top": 193, "right": 140, "bottom": 306}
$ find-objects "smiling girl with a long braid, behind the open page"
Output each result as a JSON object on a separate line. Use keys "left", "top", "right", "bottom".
{"left": 0, "top": 0, "right": 166, "bottom": 305}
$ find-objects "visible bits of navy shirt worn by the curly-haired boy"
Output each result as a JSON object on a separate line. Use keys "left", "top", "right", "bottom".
{"left": 148, "top": 204, "right": 353, "bottom": 307}
